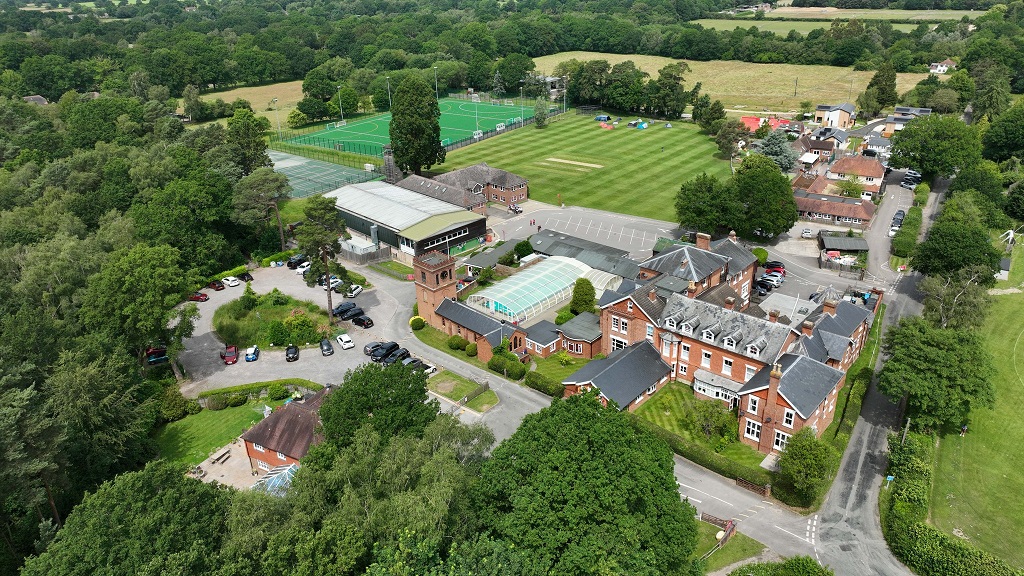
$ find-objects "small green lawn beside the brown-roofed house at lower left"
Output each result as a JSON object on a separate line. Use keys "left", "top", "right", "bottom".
{"left": 156, "top": 399, "right": 285, "bottom": 465}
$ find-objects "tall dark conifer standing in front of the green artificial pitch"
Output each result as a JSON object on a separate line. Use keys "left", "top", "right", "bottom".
{"left": 389, "top": 75, "right": 446, "bottom": 174}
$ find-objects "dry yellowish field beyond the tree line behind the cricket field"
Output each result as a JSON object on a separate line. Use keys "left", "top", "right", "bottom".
{"left": 534, "top": 52, "right": 928, "bottom": 112}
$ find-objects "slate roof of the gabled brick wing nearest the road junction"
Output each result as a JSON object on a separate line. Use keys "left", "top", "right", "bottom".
{"left": 739, "top": 354, "right": 843, "bottom": 419}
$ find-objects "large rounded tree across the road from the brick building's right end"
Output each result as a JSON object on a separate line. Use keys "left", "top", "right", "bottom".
{"left": 879, "top": 317, "right": 995, "bottom": 431}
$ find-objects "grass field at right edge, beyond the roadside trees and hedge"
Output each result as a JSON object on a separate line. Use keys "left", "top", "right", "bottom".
{"left": 931, "top": 294, "right": 1024, "bottom": 568}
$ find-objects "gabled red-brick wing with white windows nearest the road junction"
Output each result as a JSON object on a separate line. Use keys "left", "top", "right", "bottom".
{"left": 738, "top": 354, "right": 846, "bottom": 454}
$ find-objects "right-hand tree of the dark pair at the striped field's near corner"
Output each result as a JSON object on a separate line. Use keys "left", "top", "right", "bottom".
{"left": 733, "top": 154, "right": 797, "bottom": 238}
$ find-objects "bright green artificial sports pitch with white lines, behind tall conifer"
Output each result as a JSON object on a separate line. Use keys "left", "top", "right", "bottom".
{"left": 285, "top": 98, "right": 534, "bottom": 156}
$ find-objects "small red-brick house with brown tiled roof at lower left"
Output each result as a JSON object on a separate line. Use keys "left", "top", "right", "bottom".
{"left": 242, "top": 388, "right": 329, "bottom": 474}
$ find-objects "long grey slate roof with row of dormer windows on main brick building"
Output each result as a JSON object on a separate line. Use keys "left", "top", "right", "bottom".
{"left": 658, "top": 294, "right": 796, "bottom": 363}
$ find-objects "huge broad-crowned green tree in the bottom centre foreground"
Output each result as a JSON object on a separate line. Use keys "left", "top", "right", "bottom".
{"left": 474, "top": 395, "right": 696, "bottom": 574}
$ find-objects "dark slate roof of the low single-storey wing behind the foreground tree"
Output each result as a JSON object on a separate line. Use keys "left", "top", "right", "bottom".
{"left": 562, "top": 340, "right": 672, "bottom": 410}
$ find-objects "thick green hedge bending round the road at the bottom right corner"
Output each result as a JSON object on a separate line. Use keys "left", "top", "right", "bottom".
{"left": 882, "top": 434, "right": 1022, "bottom": 576}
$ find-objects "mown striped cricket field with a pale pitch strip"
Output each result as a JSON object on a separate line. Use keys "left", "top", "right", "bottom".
{"left": 440, "top": 113, "right": 729, "bottom": 219}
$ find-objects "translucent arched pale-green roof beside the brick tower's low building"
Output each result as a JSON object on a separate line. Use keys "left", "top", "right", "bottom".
{"left": 469, "top": 256, "right": 592, "bottom": 322}
